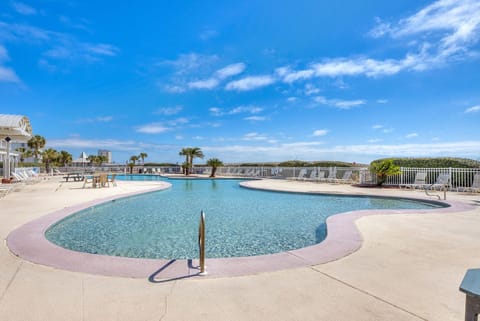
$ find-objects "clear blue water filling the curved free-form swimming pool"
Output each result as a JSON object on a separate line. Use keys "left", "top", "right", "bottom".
{"left": 45, "top": 175, "right": 446, "bottom": 259}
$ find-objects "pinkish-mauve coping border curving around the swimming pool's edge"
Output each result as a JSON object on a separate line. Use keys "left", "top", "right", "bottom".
{"left": 6, "top": 183, "right": 474, "bottom": 282}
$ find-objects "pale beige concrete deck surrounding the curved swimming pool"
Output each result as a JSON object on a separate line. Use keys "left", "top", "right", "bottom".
{"left": 0, "top": 177, "right": 480, "bottom": 321}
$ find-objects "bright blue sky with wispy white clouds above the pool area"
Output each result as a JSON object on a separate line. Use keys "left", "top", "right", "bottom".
{"left": 0, "top": 0, "right": 480, "bottom": 163}
